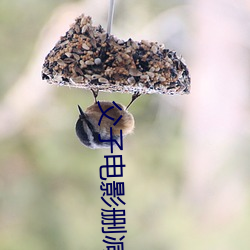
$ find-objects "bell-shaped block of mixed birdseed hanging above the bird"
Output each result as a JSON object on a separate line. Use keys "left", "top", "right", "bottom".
{"left": 42, "top": 15, "right": 190, "bottom": 94}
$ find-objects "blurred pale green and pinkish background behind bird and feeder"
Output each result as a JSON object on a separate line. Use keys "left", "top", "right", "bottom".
{"left": 0, "top": 0, "right": 250, "bottom": 250}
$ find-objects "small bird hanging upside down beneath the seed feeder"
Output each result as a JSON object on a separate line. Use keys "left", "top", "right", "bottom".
{"left": 75, "top": 90, "right": 138, "bottom": 149}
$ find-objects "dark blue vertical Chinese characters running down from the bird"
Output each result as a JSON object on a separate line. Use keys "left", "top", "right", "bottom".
{"left": 98, "top": 102, "right": 127, "bottom": 250}
